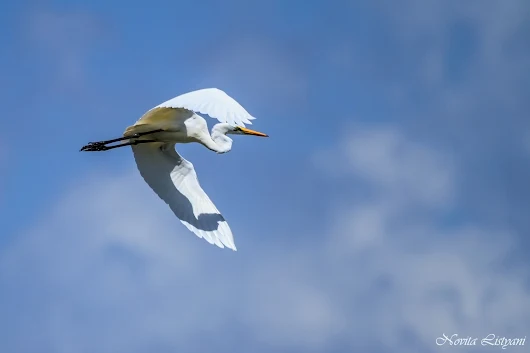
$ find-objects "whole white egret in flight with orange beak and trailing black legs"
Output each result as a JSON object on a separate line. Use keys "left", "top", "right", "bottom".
{"left": 81, "top": 88, "right": 268, "bottom": 251}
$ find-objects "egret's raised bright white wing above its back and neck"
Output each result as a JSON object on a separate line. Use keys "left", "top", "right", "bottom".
{"left": 153, "top": 88, "right": 255, "bottom": 127}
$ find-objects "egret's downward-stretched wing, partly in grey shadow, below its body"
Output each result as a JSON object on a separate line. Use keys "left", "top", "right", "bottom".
{"left": 132, "top": 143, "right": 236, "bottom": 250}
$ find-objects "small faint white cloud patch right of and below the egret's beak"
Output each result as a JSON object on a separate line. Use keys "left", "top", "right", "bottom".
{"left": 314, "top": 126, "right": 455, "bottom": 207}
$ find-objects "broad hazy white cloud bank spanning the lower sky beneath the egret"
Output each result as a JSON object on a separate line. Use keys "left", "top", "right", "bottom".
{"left": 0, "top": 127, "right": 530, "bottom": 352}
